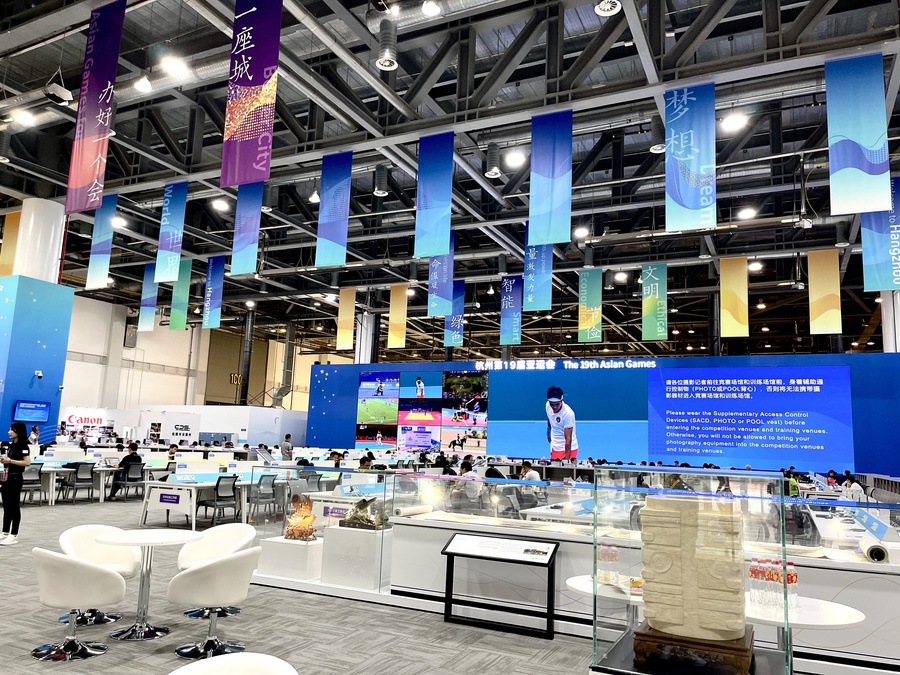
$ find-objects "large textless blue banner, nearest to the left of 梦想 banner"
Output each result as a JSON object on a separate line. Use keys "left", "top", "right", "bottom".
{"left": 525, "top": 110, "right": 572, "bottom": 246}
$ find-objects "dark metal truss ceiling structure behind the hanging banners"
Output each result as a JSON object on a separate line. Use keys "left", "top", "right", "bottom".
{"left": 0, "top": 0, "right": 900, "bottom": 360}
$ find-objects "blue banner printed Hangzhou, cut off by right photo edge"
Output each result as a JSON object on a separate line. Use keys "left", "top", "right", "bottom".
{"left": 859, "top": 177, "right": 900, "bottom": 291}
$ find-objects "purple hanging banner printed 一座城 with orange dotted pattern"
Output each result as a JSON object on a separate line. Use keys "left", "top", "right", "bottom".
{"left": 219, "top": 0, "right": 281, "bottom": 187}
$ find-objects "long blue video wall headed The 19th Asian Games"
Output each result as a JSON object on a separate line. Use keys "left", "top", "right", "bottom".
{"left": 307, "top": 354, "right": 900, "bottom": 475}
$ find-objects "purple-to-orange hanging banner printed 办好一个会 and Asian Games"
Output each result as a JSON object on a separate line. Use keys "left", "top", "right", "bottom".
{"left": 66, "top": 0, "right": 125, "bottom": 213}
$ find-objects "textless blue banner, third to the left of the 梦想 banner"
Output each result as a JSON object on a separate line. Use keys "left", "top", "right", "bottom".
{"left": 316, "top": 152, "right": 353, "bottom": 267}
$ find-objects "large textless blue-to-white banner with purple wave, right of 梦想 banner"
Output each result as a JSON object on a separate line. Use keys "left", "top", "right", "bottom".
{"left": 825, "top": 54, "right": 891, "bottom": 215}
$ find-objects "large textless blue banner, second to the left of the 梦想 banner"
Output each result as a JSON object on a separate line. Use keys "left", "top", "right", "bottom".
{"left": 413, "top": 131, "right": 453, "bottom": 258}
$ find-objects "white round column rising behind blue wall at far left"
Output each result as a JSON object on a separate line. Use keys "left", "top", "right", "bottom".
{"left": 13, "top": 198, "right": 66, "bottom": 284}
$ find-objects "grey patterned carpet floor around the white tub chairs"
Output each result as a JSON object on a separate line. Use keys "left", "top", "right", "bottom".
{"left": 0, "top": 500, "right": 591, "bottom": 675}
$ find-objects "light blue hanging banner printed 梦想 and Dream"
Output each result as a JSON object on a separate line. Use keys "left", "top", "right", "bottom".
{"left": 665, "top": 83, "right": 716, "bottom": 232}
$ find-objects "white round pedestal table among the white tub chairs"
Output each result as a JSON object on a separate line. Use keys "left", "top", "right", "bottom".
{"left": 97, "top": 529, "right": 202, "bottom": 640}
